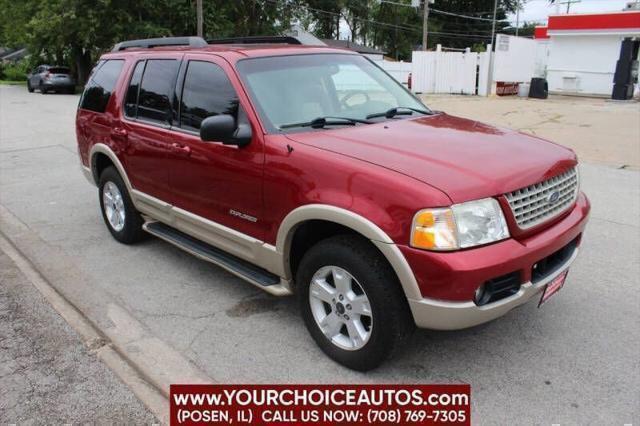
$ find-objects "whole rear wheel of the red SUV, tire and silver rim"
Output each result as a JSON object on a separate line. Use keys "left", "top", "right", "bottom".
{"left": 98, "top": 167, "right": 146, "bottom": 244}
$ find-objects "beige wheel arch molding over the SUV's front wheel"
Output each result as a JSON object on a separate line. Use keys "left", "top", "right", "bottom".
{"left": 276, "top": 204, "right": 422, "bottom": 299}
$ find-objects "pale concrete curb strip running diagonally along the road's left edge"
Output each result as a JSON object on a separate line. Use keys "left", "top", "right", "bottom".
{"left": 0, "top": 204, "right": 214, "bottom": 424}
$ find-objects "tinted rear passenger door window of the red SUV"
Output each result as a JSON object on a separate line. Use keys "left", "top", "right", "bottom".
{"left": 138, "top": 59, "right": 178, "bottom": 123}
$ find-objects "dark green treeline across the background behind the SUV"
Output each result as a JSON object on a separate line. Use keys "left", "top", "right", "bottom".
{"left": 0, "top": 0, "right": 528, "bottom": 82}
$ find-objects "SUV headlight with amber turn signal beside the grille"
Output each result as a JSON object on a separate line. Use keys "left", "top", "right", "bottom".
{"left": 411, "top": 198, "right": 509, "bottom": 250}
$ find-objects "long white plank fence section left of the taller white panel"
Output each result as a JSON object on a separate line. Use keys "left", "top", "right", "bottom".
{"left": 411, "top": 49, "right": 490, "bottom": 95}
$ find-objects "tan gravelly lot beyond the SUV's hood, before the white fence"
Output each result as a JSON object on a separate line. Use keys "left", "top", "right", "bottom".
{"left": 422, "top": 95, "right": 640, "bottom": 170}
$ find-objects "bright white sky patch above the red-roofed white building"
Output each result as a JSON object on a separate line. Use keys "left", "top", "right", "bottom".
{"left": 510, "top": 0, "right": 631, "bottom": 24}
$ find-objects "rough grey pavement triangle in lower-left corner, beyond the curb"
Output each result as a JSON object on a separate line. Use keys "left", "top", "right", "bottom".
{"left": 0, "top": 252, "right": 156, "bottom": 424}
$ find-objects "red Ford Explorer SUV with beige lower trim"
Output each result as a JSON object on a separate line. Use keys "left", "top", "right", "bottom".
{"left": 76, "top": 37, "right": 590, "bottom": 370}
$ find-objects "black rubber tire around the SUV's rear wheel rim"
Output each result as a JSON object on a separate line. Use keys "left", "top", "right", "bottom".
{"left": 98, "top": 166, "right": 147, "bottom": 244}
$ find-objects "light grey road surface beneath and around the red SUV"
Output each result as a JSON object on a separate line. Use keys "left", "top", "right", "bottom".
{"left": 0, "top": 87, "right": 640, "bottom": 424}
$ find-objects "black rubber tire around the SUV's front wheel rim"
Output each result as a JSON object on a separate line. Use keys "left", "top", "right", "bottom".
{"left": 296, "top": 235, "right": 415, "bottom": 371}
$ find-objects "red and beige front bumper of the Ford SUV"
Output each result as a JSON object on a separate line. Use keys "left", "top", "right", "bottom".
{"left": 400, "top": 193, "right": 590, "bottom": 330}
